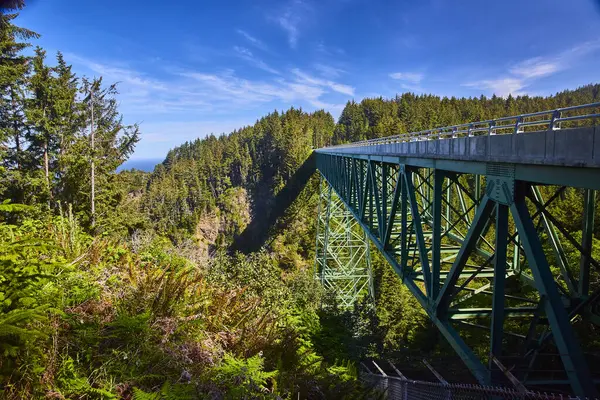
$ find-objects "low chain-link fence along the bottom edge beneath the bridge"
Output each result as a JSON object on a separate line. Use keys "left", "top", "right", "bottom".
{"left": 360, "top": 373, "right": 583, "bottom": 400}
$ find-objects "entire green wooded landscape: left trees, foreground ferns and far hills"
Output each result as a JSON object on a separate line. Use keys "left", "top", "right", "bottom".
{"left": 0, "top": 2, "right": 600, "bottom": 399}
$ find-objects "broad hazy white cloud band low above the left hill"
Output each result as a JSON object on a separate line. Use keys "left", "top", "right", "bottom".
{"left": 66, "top": 47, "right": 354, "bottom": 130}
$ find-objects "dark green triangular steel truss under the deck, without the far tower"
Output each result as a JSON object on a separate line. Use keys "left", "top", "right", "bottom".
{"left": 316, "top": 152, "right": 600, "bottom": 396}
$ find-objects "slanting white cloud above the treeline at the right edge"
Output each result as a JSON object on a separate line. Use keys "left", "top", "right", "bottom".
{"left": 462, "top": 40, "right": 600, "bottom": 97}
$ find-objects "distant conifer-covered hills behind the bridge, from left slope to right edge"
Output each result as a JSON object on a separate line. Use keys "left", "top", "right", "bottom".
{"left": 142, "top": 84, "right": 600, "bottom": 244}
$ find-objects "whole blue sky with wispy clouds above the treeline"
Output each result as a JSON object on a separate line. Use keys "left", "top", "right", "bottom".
{"left": 18, "top": 0, "right": 600, "bottom": 159}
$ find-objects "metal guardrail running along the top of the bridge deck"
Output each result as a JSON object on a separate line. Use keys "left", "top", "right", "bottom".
{"left": 326, "top": 102, "right": 600, "bottom": 149}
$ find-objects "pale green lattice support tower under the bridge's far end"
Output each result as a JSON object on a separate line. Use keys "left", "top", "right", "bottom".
{"left": 314, "top": 179, "right": 373, "bottom": 309}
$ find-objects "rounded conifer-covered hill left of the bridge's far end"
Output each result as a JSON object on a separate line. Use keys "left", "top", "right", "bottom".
{"left": 141, "top": 108, "right": 334, "bottom": 245}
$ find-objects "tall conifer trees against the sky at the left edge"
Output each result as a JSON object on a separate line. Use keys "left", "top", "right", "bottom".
{"left": 0, "top": 8, "right": 139, "bottom": 229}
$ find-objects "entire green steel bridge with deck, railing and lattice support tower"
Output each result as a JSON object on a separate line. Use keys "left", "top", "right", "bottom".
{"left": 312, "top": 103, "right": 600, "bottom": 397}
